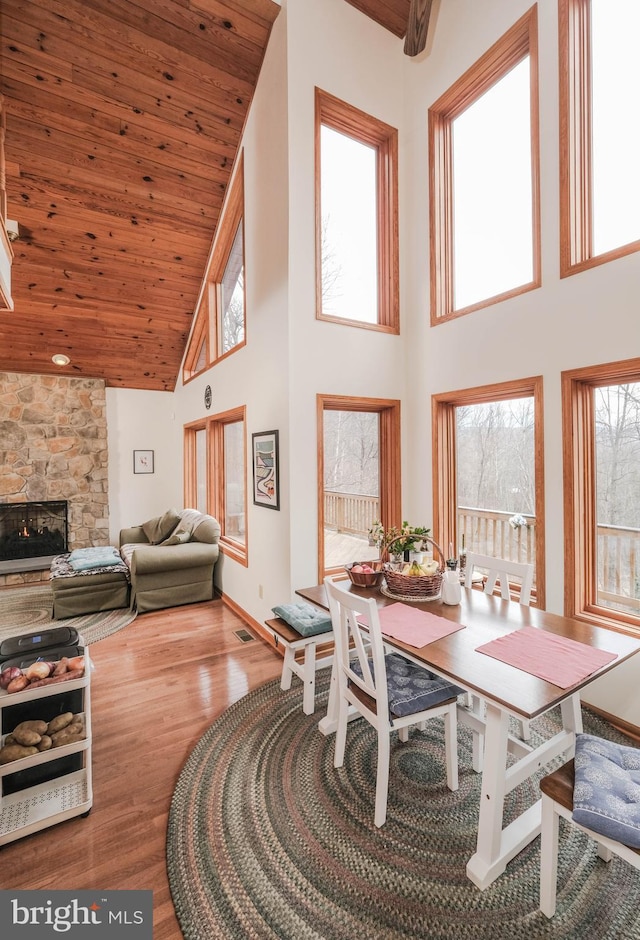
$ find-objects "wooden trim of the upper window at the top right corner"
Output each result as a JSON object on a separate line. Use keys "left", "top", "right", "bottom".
{"left": 558, "top": 0, "right": 640, "bottom": 277}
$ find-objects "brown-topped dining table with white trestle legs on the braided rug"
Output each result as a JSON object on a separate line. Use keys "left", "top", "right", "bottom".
{"left": 296, "top": 581, "right": 640, "bottom": 890}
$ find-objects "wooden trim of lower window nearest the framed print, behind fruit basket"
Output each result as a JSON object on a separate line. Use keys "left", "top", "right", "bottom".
{"left": 316, "top": 395, "right": 402, "bottom": 582}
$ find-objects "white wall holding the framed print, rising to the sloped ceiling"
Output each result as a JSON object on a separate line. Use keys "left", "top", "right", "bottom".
{"left": 170, "top": 9, "right": 290, "bottom": 621}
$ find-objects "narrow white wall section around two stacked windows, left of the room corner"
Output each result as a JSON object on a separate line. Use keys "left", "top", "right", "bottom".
{"left": 287, "top": 0, "right": 406, "bottom": 589}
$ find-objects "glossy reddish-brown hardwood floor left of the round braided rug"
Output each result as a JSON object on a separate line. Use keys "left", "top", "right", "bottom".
{"left": 0, "top": 601, "right": 282, "bottom": 940}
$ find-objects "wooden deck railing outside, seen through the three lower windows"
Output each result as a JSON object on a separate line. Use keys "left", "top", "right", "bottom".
{"left": 324, "top": 492, "right": 640, "bottom": 614}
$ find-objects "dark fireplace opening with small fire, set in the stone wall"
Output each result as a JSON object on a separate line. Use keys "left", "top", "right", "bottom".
{"left": 0, "top": 500, "right": 68, "bottom": 571}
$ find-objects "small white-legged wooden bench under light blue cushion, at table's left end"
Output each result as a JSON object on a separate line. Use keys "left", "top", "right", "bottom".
{"left": 265, "top": 617, "right": 333, "bottom": 715}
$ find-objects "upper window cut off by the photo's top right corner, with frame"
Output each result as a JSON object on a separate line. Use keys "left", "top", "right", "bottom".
{"left": 559, "top": 0, "right": 640, "bottom": 277}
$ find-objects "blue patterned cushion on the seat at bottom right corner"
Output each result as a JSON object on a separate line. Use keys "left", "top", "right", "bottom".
{"left": 573, "top": 734, "right": 640, "bottom": 849}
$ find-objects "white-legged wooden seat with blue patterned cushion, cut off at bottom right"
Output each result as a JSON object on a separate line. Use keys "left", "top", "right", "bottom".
{"left": 540, "top": 735, "right": 640, "bottom": 917}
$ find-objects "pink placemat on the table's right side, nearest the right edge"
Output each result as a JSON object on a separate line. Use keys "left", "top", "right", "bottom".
{"left": 477, "top": 627, "right": 617, "bottom": 689}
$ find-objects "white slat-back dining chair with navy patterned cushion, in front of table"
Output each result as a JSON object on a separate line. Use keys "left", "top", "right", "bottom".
{"left": 324, "top": 578, "right": 464, "bottom": 826}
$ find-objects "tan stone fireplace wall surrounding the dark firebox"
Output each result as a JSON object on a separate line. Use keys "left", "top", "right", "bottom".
{"left": 0, "top": 372, "right": 109, "bottom": 586}
